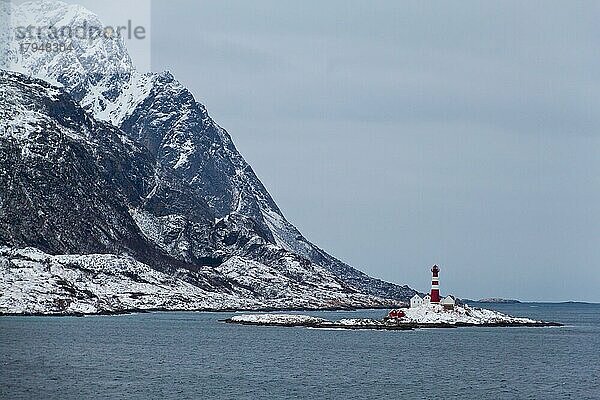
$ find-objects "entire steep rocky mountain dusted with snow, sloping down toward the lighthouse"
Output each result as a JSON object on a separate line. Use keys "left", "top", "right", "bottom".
{"left": 0, "top": 1, "right": 415, "bottom": 313}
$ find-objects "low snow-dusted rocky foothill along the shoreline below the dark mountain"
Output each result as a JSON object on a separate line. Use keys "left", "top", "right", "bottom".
{"left": 0, "top": 247, "right": 392, "bottom": 314}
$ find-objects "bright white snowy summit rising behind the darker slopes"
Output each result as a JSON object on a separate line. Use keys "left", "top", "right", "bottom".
{"left": 2, "top": 0, "right": 139, "bottom": 114}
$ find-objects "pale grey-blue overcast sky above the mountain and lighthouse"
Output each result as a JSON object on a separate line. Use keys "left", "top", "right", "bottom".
{"left": 79, "top": 0, "right": 600, "bottom": 301}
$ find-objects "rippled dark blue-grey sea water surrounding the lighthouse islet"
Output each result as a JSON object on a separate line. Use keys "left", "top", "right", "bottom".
{"left": 0, "top": 304, "right": 600, "bottom": 400}
